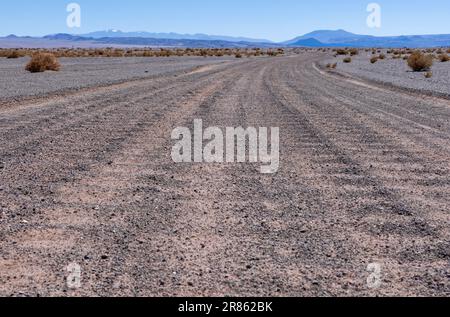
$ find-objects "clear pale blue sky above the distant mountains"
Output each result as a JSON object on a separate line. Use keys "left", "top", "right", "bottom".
{"left": 0, "top": 0, "right": 450, "bottom": 41}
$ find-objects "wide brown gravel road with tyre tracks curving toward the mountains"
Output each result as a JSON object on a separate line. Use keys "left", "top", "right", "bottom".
{"left": 0, "top": 53, "right": 450, "bottom": 296}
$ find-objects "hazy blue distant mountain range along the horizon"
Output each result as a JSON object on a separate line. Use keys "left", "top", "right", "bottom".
{"left": 0, "top": 30, "right": 450, "bottom": 48}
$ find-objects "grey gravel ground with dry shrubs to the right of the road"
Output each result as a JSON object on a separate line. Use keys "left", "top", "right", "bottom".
{"left": 322, "top": 52, "right": 450, "bottom": 97}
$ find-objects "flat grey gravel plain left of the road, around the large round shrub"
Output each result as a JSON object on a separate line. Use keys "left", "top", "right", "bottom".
{"left": 0, "top": 57, "right": 233, "bottom": 100}
